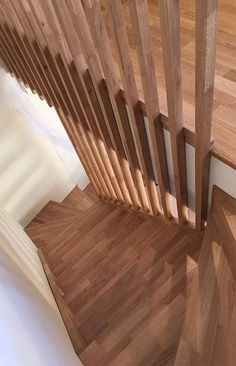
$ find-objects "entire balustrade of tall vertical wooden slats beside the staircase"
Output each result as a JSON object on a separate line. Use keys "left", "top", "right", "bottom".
{"left": 0, "top": 0, "right": 217, "bottom": 229}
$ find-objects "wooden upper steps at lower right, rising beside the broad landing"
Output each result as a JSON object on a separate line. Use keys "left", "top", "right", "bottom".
{"left": 175, "top": 187, "right": 236, "bottom": 366}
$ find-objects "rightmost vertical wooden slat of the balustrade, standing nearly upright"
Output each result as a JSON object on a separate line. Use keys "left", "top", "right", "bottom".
{"left": 195, "top": 0, "right": 218, "bottom": 229}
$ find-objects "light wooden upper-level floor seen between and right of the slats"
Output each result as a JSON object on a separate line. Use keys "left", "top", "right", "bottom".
{"left": 100, "top": 0, "right": 236, "bottom": 168}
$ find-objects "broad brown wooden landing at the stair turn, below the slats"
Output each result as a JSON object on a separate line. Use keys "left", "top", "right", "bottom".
{"left": 26, "top": 190, "right": 202, "bottom": 366}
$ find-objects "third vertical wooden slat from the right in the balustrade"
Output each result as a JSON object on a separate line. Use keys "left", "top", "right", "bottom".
{"left": 129, "top": 0, "right": 171, "bottom": 218}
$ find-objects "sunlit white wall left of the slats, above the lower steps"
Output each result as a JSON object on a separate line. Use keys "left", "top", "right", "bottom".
{"left": 0, "top": 59, "right": 89, "bottom": 226}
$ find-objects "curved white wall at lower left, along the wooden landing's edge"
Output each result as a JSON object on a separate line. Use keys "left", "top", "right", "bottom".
{"left": 0, "top": 209, "right": 82, "bottom": 366}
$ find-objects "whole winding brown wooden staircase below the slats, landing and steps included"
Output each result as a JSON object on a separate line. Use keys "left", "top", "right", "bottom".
{"left": 26, "top": 186, "right": 236, "bottom": 366}
